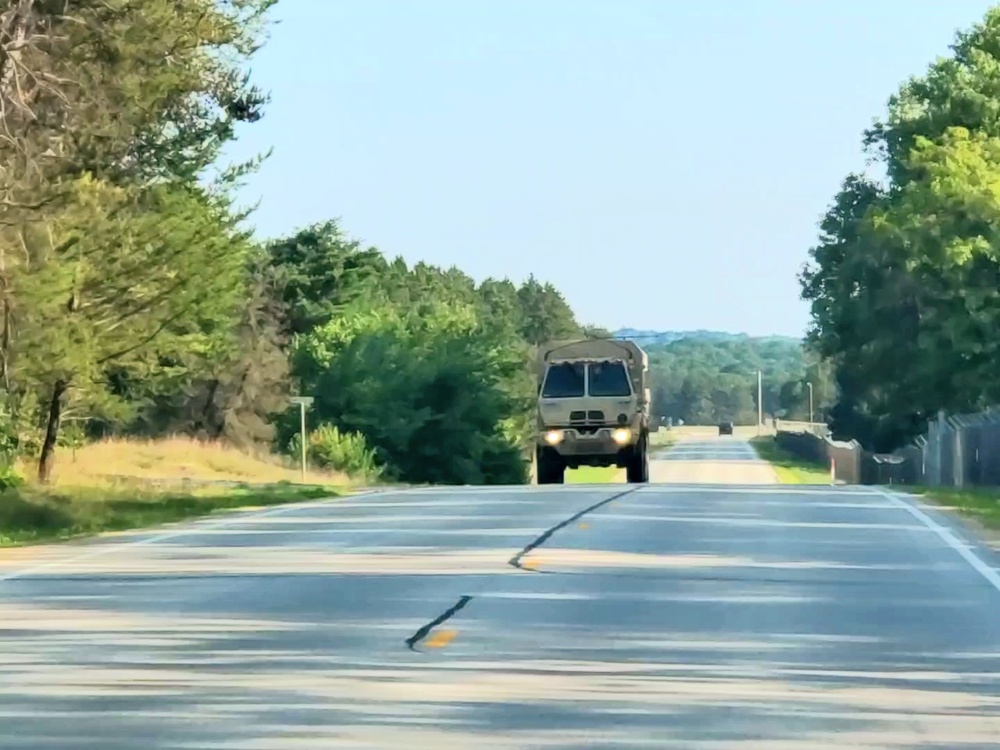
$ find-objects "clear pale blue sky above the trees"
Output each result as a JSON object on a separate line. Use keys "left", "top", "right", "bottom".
{"left": 223, "top": 0, "right": 992, "bottom": 335}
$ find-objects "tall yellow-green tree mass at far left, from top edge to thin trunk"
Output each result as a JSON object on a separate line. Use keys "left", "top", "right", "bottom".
{"left": 0, "top": 0, "right": 272, "bottom": 481}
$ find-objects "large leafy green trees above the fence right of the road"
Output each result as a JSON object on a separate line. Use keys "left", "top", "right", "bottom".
{"left": 801, "top": 8, "right": 1000, "bottom": 451}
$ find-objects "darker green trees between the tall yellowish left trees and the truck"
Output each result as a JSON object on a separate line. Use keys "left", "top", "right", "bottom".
{"left": 266, "top": 222, "right": 585, "bottom": 484}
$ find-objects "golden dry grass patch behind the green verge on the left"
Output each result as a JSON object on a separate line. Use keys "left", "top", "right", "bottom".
{"left": 13, "top": 436, "right": 350, "bottom": 487}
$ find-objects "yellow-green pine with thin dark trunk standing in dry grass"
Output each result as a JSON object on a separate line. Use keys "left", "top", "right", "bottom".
{"left": 13, "top": 178, "right": 252, "bottom": 481}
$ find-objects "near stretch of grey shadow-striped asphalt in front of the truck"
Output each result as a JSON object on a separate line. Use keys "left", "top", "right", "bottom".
{"left": 0, "top": 438, "right": 1000, "bottom": 750}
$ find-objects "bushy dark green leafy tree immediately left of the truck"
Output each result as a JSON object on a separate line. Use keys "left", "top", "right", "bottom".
{"left": 293, "top": 303, "right": 529, "bottom": 484}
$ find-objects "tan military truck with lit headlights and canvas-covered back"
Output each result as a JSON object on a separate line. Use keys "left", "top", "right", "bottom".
{"left": 535, "top": 339, "right": 655, "bottom": 484}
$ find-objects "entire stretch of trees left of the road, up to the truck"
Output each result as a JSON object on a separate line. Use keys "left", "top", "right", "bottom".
{"left": 0, "top": 0, "right": 600, "bottom": 483}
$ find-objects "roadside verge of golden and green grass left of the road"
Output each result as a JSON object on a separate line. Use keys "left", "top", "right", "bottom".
{"left": 0, "top": 437, "right": 358, "bottom": 546}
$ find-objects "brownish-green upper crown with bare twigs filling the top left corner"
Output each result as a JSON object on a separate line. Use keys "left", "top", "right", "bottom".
{"left": 0, "top": 0, "right": 275, "bottom": 216}
